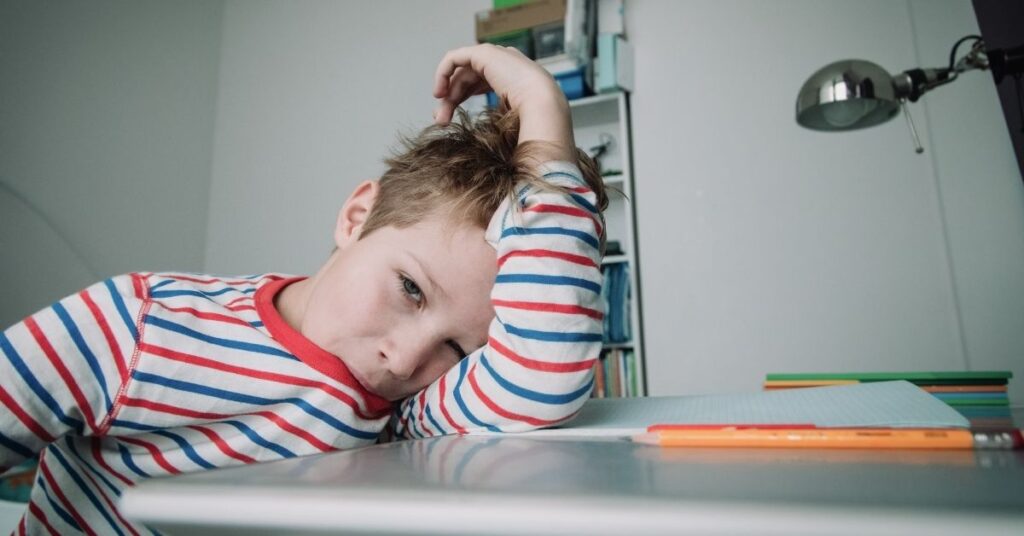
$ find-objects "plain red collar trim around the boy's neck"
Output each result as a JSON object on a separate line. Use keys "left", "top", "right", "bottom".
{"left": 254, "top": 278, "right": 391, "bottom": 415}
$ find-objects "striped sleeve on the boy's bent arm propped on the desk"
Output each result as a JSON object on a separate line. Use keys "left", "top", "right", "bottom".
{"left": 392, "top": 162, "right": 604, "bottom": 438}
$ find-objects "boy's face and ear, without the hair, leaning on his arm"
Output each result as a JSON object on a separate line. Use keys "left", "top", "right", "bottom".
{"left": 301, "top": 182, "right": 498, "bottom": 400}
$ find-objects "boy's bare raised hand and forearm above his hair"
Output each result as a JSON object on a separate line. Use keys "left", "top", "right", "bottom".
{"left": 434, "top": 44, "right": 575, "bottom": 161}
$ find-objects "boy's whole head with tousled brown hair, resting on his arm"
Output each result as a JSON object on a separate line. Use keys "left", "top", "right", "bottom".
{"left": 299, "top": 107, "right": 607, "bottom": 400}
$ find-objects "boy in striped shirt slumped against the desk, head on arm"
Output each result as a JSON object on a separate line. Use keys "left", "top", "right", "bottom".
{"left": 0, "top": 45, "right": 607, "bottom": 534}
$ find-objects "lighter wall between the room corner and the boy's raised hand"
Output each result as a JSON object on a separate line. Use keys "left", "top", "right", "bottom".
{"left": 206, "top": 0, "right": 489, "bottom": 274}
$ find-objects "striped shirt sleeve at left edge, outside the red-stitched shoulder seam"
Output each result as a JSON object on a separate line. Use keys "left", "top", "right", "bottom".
{"left": 0, "top": 276, "right": 144, "bottom": 472}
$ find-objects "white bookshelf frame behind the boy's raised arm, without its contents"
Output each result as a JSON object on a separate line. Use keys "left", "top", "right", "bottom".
{"left": 569, "top": 92, "right": 647, "bottom": 397}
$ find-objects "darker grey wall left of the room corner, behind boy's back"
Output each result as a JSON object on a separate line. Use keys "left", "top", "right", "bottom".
{"left": 0, "top": 0, "right": 222, "bottom": 327}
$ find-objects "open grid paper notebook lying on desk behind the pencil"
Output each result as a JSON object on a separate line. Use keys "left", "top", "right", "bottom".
{"left": 550, "top": 381, "right": 969, "bottom": 434}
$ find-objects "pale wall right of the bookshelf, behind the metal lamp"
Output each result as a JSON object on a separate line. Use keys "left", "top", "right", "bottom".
{"left": 627, "top": 0, "right": 1024, "bottom": 403}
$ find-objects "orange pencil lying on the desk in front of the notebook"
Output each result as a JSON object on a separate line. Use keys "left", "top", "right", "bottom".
{"left": 633, "top": 427, "right": 1024, "bottom": 449}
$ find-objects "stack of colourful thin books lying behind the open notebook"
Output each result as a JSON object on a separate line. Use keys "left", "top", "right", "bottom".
{"left": 764, "top": 371, "right": 1013, "bottom": 428}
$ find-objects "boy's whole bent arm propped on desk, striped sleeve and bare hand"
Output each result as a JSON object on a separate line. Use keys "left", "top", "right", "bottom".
{"left": 396, "top": 45, "right": 603, "bottom": 437}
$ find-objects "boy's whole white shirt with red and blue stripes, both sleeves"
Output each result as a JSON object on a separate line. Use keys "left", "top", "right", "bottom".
{"left": 0, "top": 162, "right": 602, "bottom": 534}
